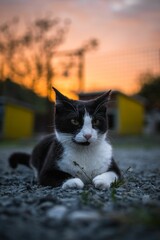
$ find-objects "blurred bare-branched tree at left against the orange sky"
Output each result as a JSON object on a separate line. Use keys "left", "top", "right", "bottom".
{"left": 0, "top": 17, "right": 69, "bottom": 97}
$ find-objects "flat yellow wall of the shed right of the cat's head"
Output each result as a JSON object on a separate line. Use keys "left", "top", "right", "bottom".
{"left": 117, "top": 94, "right": 144, "bottom": 134}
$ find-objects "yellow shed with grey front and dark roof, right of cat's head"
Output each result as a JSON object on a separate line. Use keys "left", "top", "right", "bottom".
{"left": 79, "top": 91, "right": 144, "bottom": 135}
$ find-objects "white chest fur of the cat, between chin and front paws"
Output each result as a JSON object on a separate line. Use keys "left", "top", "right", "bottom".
{"left": 58, "top": 140, "right": 112, "bottom": 183}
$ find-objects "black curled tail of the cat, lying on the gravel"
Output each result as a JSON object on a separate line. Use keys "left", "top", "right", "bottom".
{"left": 8, "top": 152, "right": 31, "bottom": 169}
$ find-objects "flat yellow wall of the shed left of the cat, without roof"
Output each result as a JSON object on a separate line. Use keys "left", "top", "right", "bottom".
{"left": 3, "top": 104, "right": 34, "bottom": 138}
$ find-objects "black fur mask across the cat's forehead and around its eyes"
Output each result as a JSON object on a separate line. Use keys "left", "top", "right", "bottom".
{"left": 55, "top": 100, "right": 108, "bottom": 135}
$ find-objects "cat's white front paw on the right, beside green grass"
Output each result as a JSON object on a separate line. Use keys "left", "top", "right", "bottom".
{"left": 93, "top": 172, "right": 118, "bottom": 190}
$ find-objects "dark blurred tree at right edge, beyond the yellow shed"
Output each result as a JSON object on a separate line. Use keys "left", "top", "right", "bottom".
{"left": 139, "top": 73, "right": 160, "bottom": 109}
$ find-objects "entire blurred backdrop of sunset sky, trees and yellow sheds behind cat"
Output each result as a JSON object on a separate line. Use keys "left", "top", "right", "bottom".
{"left": 0, "top": 0, "right": 160, "bottom": 142}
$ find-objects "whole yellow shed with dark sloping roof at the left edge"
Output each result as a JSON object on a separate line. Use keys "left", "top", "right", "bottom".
{"left": 0, "top": 98, "right": 34, "bottom": 139}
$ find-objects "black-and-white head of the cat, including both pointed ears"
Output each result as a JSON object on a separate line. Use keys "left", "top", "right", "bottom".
{"left": 53, "top": 88, "right": 111, "bottom": 146}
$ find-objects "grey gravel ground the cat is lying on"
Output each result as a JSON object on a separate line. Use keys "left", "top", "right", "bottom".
{"left": 0, "top": 137, "right": 160, "bottom": 240}
